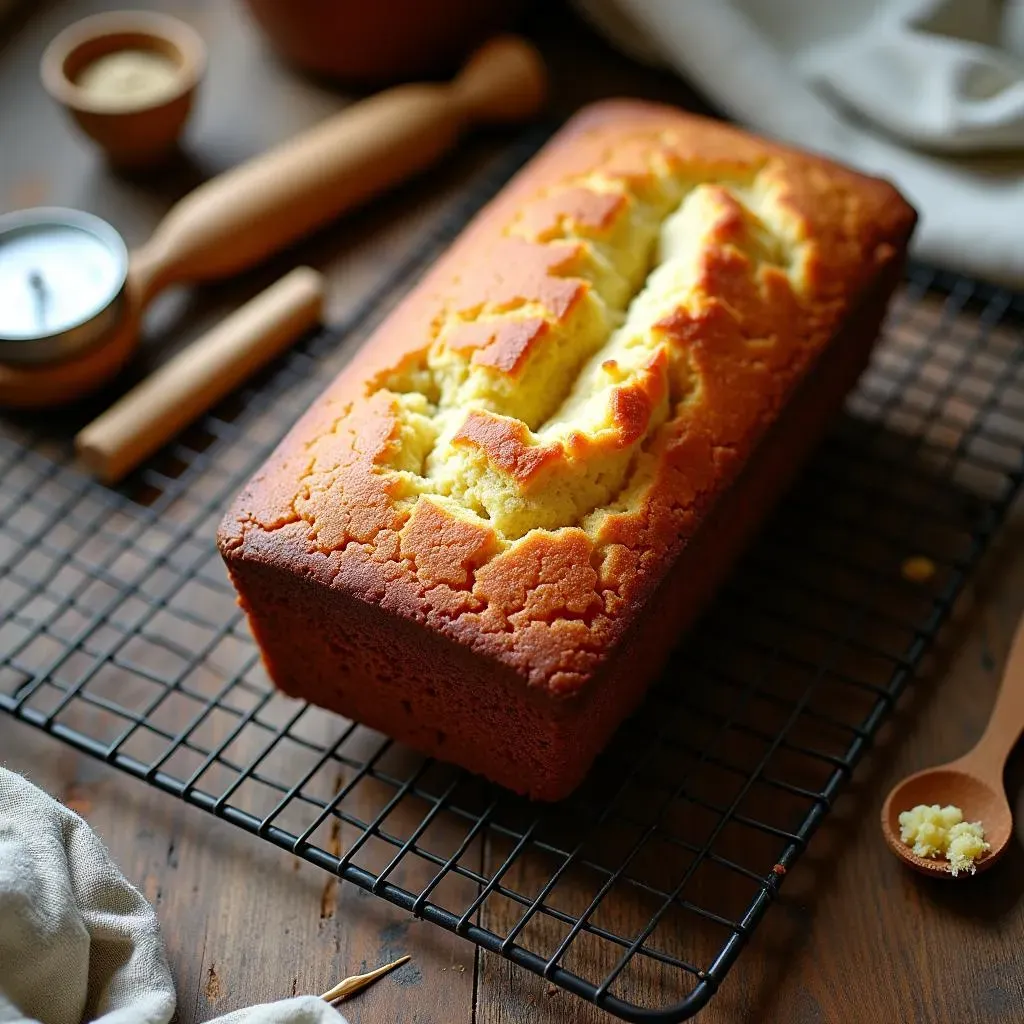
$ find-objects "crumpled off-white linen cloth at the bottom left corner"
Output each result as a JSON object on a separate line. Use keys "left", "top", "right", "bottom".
{"left": 0, "top": 767, "right": 345, "bottom": 1024}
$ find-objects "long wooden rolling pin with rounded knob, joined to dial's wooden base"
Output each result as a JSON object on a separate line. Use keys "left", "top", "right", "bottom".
{"left": 0, "top": 36, "right": 546, "bottom": 408}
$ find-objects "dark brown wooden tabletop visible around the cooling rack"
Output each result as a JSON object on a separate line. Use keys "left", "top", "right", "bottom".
{"left": 0, "top": 0, "right": 1024, "bottom": 1024}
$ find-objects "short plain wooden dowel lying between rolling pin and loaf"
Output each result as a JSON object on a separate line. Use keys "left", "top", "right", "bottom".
{"left": 75, "top": 266, "right": 324, "bottom": 483}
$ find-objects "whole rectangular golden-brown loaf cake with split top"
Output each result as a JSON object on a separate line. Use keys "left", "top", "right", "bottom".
{"left": 218, "top": 100, "right": 914, "bottom": 800}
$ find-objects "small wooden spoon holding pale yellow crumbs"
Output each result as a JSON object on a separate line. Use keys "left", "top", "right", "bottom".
{"left": 882, "top": 618, "right": 1024, "bottom": 878}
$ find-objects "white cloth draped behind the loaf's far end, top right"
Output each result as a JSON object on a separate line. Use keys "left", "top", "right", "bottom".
{"left": 574, "top": 0, "right": 1024, "bottom": 287}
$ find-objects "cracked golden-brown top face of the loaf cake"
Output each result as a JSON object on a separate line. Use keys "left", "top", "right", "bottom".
{"left": 220, "top": 101, "right": 913, "bottom": 694}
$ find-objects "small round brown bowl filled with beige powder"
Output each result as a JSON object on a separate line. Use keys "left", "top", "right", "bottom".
{"left": 40, "top": 11, "right": 206, "bottom": 169}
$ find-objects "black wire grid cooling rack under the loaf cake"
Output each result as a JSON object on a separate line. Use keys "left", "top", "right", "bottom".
{"left": 0, "top": 132, "right": 1024, "bottom": 1021}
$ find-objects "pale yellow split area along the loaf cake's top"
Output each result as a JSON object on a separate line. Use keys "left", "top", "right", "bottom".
{"left": 290, "top": 150, "right": 803, "bottom": 550}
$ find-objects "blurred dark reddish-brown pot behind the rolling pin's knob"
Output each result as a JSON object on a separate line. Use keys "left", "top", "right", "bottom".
{"left": 240, "top": 0, "right": 527, "bottom": 85}
